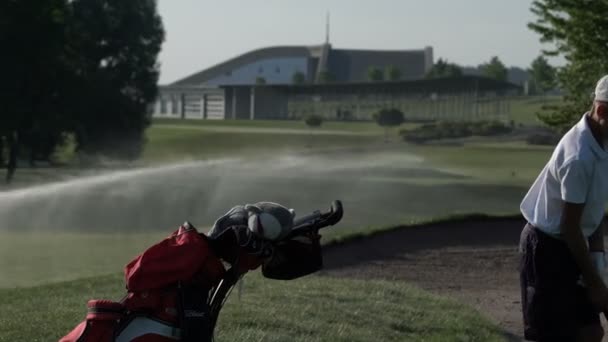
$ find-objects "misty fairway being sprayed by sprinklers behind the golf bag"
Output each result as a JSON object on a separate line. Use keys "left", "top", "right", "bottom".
{"left": 0, "top": 122, "right": 551, "bottom": 287}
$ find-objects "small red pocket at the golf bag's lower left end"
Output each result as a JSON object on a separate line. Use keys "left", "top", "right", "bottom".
{"left": 59, "top": 300, "right": 125, "bottom": 342}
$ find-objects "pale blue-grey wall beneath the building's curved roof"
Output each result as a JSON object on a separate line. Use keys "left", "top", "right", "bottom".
{"left": 204, "top": 57, "right": 310, "bottom": 86}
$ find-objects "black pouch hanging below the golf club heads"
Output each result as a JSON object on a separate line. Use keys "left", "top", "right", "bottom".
{"left": 262, "top": 236, "right": 323, "bottom": 280}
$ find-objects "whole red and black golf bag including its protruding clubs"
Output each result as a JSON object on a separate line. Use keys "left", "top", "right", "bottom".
{"left": 60, "top": 201, "right": 342, "bottom": 342}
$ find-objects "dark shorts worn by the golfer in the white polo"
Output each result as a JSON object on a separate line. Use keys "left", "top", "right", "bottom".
{"left": 520, "top": 225, "right": 600, "bottom": 341}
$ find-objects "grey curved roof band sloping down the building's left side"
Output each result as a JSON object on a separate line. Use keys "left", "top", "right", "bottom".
{"left": 171, "top": 46, "right": 319, "bottom": 85}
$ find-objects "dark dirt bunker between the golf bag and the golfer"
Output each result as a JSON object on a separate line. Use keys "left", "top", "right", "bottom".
{"left": 323, "top": 219, "right": 524, "bottom": 341}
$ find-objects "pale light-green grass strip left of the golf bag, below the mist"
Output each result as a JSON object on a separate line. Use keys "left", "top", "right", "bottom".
{"left": 0, "top": 231, "right": 170, "bottom": 288}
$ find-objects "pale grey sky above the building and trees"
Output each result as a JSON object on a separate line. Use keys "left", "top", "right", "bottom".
{"left": 158, "top": 0, "right": 560, "bottom": 84}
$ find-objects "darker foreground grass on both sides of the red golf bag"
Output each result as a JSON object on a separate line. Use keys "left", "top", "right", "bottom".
{"left": 0, "top": 274, "right": 504, "bottom": 342}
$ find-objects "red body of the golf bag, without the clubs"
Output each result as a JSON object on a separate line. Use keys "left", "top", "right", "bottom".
{"left": 60, "top": 224, "right": 225, "bottom": 342}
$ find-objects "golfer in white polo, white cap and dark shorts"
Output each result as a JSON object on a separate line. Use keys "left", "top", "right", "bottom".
{"left": 520, "top": 76, "right": 608, "bottom": 342}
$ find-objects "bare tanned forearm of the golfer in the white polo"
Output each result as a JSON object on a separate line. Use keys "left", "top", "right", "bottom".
{"left": 561, "top": 203, "right": 602, "bottom": 287}
